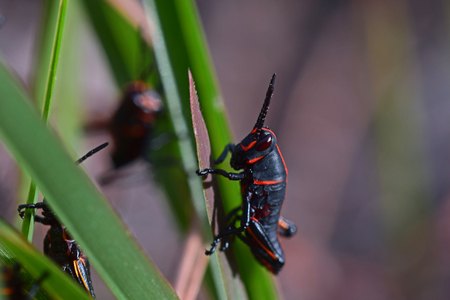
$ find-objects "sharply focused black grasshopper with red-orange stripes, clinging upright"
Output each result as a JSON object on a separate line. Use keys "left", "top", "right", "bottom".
{"left": 197, "top": 74, "right": 296, "bottom": 274}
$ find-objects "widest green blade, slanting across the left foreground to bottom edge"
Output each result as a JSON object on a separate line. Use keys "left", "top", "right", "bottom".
{"left": 0, "top": 65, "right": 177, "bottom": 299}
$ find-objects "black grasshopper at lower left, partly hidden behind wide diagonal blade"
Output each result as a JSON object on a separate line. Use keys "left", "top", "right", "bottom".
{"left": 18, "top": 143, "right": 108, "bottom": 298}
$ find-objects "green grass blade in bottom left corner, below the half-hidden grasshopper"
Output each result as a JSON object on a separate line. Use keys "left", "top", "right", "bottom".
{"left": 0, "top": 219, "right": 92, "bottom": 300}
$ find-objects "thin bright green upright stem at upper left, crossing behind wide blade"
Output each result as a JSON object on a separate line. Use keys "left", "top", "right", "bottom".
{"left": 22, "top": 0, "right": 68, "bottom": 242}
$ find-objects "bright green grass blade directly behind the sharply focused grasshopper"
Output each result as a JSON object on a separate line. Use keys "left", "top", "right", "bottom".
{"left": 144, "top": 1, "right": 279, "bottom": 299}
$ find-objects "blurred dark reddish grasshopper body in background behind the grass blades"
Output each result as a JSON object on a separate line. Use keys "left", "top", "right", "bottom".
{"left": 110, "top": 81, "right": 163, "bottom": 169}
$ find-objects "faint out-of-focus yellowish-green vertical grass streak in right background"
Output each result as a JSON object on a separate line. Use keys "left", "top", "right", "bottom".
{"left": 366, "top": 1, "right": 429, "bottom": 243}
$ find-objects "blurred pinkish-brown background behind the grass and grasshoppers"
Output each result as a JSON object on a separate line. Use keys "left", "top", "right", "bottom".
{"left": 0, "top": 0, "right": 450, "bottom": 300}
